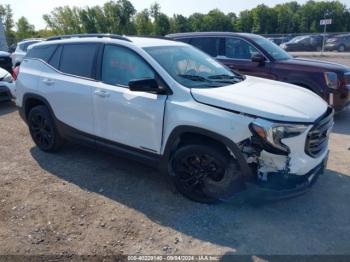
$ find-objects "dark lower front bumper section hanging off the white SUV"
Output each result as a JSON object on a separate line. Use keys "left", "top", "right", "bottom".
{"left": 245, "top": 154, "right": 328, "bottom": 202}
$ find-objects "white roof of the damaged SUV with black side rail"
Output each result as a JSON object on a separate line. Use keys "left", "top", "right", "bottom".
{"left": 31, "top": 36, "right": 186, "bottom": 48}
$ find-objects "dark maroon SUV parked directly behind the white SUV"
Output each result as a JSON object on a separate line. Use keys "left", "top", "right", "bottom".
{"left": 166, "top": 32, "right": 350, "bottom": 111}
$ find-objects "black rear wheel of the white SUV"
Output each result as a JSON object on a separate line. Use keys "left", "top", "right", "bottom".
{"left": 28, "top": 105, "right": 63, "bottom": 153}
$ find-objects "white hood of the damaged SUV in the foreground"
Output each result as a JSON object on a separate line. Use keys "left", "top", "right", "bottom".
{"left": 191, "top": 76, "right": 328, "bottom": 123}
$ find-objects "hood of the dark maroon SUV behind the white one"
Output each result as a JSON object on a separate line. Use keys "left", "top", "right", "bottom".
{"left": 277, "top": 58, "right": 350, "bottom": 72}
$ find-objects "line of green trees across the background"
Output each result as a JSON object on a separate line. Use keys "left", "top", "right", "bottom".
{"left": 0, "top": 0, "right": 350, "bottom": 44}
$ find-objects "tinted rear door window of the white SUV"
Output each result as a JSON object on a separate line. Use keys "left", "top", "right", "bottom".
{"left": 59, "top": 43, "right": 97, "bottom": 78}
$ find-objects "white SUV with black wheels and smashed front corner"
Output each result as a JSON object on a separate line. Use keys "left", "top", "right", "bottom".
{"left": 16, "top": 35, "right": 333, "bottom": 203}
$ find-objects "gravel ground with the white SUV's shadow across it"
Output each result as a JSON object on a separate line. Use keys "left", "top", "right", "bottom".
{"left": 0, "top": 54, "right": 350, "bottom": 255}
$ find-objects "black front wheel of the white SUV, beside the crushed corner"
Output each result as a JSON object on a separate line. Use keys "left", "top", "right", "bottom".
{"left": 170, "top": 144, "right": 244, "bottom": 204}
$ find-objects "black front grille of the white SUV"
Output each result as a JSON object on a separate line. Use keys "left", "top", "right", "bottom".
{"left": 305, "top": 107, "right": 334, "bottom": 158}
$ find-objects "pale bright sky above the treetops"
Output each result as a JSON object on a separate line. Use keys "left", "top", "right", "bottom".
{"left": 1, "top": 0, "right": 350, "bottom": 29}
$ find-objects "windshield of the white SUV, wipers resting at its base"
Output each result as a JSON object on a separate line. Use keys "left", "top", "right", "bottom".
{"left": 144, "top": 46, "right": 244, "bottom": 88}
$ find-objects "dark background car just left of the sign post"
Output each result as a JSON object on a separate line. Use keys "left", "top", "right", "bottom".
{"left": 281, "top": 35, "right": 323, "bottom": 52}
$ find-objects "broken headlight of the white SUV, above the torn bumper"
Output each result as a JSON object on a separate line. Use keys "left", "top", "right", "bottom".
{"left": 249, "top": 119, "right": 307, "bottom": 155}
